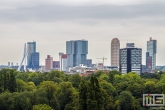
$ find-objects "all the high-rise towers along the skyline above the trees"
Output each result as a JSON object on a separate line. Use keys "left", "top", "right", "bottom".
{"left": 19, "top": 38, "right": 157, "bottom": 74}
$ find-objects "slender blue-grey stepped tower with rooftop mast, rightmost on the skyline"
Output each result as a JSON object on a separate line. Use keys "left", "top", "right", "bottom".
{"left": 146, "top": 37, "right": 157, "bottom": 71}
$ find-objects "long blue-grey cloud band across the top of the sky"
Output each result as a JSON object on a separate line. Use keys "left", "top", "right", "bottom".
{"left": 0, "top": 4, "right": 165, "bottom": 22}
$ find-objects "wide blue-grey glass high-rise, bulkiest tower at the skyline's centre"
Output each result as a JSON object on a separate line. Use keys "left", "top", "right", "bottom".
{"left": 66, "top": 40, "right": 88, "bottom": 68}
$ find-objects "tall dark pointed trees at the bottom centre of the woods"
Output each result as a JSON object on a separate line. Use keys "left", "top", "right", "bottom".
{"left": 79, "top": 77, "right": 104, "bottom": 110}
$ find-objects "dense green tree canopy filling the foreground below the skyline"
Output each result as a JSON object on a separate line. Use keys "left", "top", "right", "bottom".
{"left": 0, "top": 69, "right": 165, "bottom": 110}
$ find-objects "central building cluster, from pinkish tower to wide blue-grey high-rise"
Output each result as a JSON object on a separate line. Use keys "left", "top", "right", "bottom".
{"left": 45, "top": 40, "right": 90, "bottom": 71}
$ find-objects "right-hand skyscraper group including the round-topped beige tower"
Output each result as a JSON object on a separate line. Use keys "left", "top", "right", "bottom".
{"left": 111, "top": 38, "right": 157, "bottom": 74}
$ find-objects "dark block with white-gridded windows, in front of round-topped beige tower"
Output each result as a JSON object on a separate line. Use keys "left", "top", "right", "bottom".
{"left": 119, "top": 43, "right": 142, "bottom": 74}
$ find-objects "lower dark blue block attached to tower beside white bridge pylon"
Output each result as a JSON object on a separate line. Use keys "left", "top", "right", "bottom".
{"left": 31, "top": 52, "right": 39, "bottom": 69}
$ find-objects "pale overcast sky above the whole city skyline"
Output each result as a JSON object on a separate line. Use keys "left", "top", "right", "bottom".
{"left": 0, "top": 0, "right": 165, "bottom": 65}
